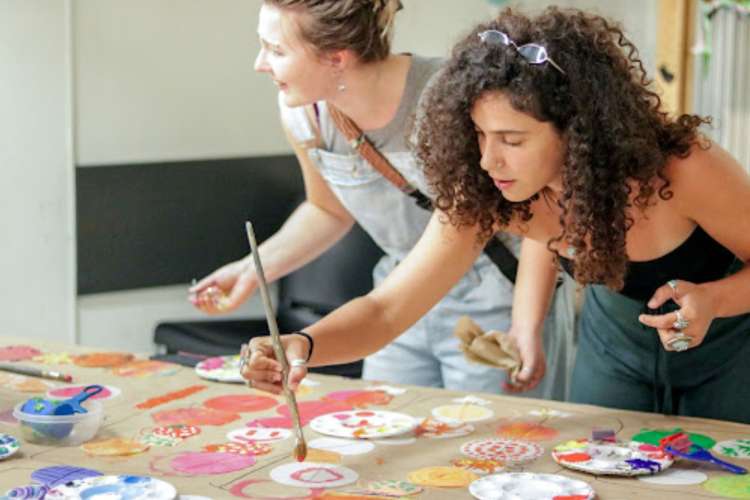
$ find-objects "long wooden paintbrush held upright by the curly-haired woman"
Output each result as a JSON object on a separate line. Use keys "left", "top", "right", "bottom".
{"left": 245, "top": 221, "right": 307, "bottom": 462}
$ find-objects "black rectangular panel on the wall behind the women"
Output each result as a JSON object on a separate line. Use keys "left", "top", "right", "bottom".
{"left": 76, "top": 155, "right": 304, "bottom": 294}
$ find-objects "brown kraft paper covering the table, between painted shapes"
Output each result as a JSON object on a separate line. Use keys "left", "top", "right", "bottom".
{"left": 0, "top": 337, "right": 750, "bottom": 500}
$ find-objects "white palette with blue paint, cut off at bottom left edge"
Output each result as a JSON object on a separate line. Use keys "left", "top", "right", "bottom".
{"left": 44, "top": 476, "right": 177, "bottom": 500}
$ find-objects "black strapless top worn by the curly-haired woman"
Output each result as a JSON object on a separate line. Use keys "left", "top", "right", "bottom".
{"left": 560, "top": 226, "right": 735, "bottom": 301}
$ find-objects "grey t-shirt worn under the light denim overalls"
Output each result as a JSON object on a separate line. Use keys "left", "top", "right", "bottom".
{"left": 320, "top": 55, "right": 445, "bottom": 154}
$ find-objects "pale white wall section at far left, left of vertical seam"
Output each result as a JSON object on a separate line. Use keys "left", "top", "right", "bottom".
{"left": 0, "top": 0, "right": 75, "bottom": 342}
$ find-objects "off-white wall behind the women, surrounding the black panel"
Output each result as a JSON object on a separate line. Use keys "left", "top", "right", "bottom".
{"left": 0, "top": 0, "right": 656, "bottom": 351}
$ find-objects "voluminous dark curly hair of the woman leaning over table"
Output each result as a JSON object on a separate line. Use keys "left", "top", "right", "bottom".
{"left": 415, "top": 7, "right": 709, "bottom": 290}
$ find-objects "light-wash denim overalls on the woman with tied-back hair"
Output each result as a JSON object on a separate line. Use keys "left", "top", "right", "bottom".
{"left": 280, "top": 93, "right": 573, "bottom": 399}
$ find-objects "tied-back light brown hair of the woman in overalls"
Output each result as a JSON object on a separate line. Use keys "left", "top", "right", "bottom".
{"left": 264, "top": 0, "right": 402, "bottom": 63}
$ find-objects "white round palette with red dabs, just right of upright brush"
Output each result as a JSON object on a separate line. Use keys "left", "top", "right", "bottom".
{"left": 310, "top": 410, "right": 419, "bottom": 439}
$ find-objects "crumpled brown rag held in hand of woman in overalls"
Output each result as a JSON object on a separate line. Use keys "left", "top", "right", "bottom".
{"left": 453, "top": 316, "right": 521, "bottom": 381}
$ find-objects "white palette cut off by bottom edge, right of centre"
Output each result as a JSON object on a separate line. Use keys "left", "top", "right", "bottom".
{"left": 469, "top": 472, "right": 595, "bottom": 500}
